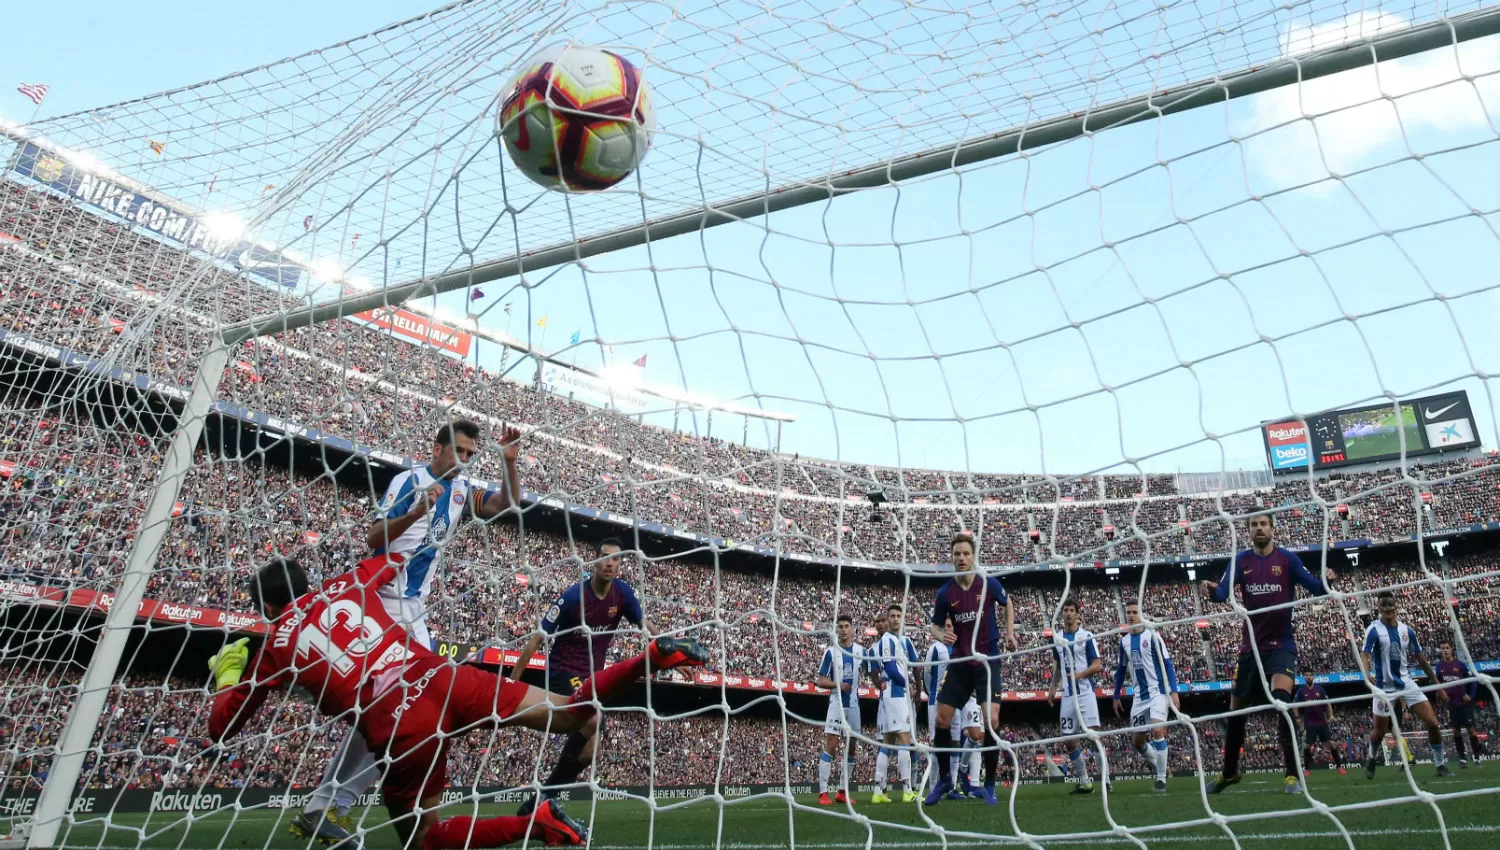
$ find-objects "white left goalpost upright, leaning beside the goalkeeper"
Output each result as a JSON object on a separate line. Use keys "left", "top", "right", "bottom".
{"left": 27, "top": 337, "right": 230, "bottom": 849}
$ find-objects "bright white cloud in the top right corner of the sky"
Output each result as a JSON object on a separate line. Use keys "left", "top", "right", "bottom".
{"left": 1233, "top": 12, "right": 1500, "bottom": 192}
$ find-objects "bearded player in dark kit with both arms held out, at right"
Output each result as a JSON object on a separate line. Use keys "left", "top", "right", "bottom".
{"left": 1203, "top": 514, "right": 1334, "bottom": 795}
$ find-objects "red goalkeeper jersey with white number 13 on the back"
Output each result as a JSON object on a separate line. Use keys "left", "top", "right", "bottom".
{"left": 209, "top": 555, "right": 432, "bottom": 741}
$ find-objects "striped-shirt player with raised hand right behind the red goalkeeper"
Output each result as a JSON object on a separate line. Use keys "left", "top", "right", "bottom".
{"left": 291, "top": 420, "right": 521, "bottom": 844}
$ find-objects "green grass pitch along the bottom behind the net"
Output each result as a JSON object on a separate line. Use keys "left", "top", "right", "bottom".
{"left": 32, "top": 763, "right": 1500, "bottom": 850}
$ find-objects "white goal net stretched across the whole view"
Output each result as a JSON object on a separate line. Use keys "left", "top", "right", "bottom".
{"left": 0, "top": 0, "right": 1500, "bottom": 850}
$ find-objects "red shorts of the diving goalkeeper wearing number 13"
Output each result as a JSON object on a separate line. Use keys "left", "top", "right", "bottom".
{"left": 360, "top": 660, "right": 530, "bottom": 810}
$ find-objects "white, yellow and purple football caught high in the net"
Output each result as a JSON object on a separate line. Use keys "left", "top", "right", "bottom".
{"left": 498, "top": 45, "right": 656, "bottom": 192}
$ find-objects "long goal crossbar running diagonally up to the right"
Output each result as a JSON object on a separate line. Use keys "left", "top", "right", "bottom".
{"left": 225, "top": 7, "right": 1500, "bottom": 343}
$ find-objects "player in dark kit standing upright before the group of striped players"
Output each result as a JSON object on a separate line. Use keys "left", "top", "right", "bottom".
{"left": 926, "top": 534, "right": 1017, "bottom": 805}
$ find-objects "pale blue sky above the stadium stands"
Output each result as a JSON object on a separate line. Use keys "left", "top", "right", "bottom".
{"left": 0, "top": 0, "right": 1500, "bottom": 474}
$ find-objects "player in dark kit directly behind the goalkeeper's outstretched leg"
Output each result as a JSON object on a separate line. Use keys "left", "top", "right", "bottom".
{"left": 510, "top": 537, "right": 656, "bottom": 814}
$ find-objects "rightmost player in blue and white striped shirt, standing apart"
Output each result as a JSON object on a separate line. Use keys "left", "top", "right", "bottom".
{"left": 1359, "top": 591, "right": 1454, "bottom": 780}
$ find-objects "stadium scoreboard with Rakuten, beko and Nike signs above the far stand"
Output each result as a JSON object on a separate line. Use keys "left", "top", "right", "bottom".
{"left": 1262, "top": 391, "right": 1479, "bottom": 474}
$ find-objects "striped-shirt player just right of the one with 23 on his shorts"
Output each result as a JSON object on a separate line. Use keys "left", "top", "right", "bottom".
{"left": 1115, "top": 603, "right": 1182, "bottom": 792}
